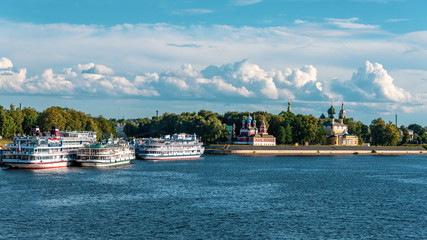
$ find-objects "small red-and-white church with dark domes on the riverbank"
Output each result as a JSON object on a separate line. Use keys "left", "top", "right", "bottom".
{"left": 234, "top": 115, "right": 276, "bottom": 146}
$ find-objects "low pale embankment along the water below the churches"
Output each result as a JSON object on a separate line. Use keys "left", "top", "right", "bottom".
{"left": 205, "top": 145, "right": 427, "bottom": 156}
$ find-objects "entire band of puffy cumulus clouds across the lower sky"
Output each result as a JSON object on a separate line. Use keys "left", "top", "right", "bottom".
{"left": 0, "top": 56, "right": 418, "bottom": 111}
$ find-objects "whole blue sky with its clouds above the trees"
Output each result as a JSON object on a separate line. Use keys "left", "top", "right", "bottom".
{"left": 0, "top": 0, "right": 427, "bottom": 125}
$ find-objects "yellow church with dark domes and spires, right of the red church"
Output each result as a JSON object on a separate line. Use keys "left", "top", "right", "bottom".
{"left": 320, "top": 103, "right": 359, "bottom": 146}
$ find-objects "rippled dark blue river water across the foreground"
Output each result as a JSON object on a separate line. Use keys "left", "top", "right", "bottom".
{"left": 0, "top": 155, "right": 427, "bottom": 239}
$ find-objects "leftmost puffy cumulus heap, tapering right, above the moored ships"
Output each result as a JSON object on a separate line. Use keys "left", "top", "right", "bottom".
{"left": 0, "top": 59, "right": 159, "bottom": 97}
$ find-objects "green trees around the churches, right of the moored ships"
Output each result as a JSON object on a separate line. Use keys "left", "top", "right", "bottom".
{"left": 124, "top": 110, "right": 427, "bottom": 146}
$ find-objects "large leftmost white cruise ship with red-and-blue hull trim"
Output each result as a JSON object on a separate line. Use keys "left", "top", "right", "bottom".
{"left": 2, "top": 127, "right": 96, "bottom": 169}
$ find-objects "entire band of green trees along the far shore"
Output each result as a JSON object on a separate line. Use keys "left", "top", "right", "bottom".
{"left": 0, "top": 105, "right": 427, "bottom": 146}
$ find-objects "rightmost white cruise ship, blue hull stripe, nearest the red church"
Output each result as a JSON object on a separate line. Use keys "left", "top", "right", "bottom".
{"left": 137, "top": 133, "right": 205, "bottom": 160}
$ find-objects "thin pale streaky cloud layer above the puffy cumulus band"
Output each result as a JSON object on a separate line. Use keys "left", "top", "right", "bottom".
{"left": 0, "top": 18, "right": 427, "bottom": 81}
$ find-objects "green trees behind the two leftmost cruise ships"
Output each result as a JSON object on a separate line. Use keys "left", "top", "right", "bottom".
{"left": 0, "top": 105, "right": 117, "bottom": 140}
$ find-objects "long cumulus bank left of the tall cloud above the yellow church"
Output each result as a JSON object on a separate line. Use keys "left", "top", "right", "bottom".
{"left": 0, "top": 57, "right": 328, "bottom": 101}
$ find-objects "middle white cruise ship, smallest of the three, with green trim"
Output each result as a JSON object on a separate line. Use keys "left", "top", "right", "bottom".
{"left": 76, "top": 139, "right": 135, "bottom": 167}
